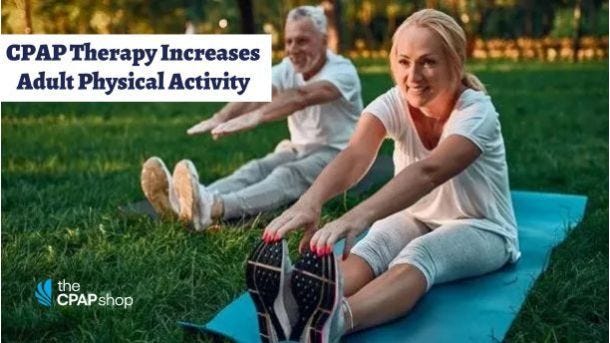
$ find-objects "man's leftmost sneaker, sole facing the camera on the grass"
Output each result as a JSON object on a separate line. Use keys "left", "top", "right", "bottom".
{"left": 140, "top": 156, "right": 178, "bottom": 218}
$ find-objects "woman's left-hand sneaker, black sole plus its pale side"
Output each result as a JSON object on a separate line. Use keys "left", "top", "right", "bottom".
{"left": 246, "top": 239, "right": 296, "bottom": 343}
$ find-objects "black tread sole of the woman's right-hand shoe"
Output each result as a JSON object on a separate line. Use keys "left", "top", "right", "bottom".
{"left": 290, "top": 250, "right": 338, "bottom": 343}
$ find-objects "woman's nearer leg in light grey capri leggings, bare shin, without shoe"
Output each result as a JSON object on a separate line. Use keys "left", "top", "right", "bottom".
{"left": 348, "top": 224, "right": 509, "bottom": 331}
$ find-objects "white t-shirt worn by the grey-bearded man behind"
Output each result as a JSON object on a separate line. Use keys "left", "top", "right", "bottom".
{"left": 272, "top": 50, "right": 362, "bottom": 149}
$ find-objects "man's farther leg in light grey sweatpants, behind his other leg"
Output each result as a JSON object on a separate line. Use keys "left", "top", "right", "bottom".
{"left": 206, "top": 150, "right": 297, "bottom": 194}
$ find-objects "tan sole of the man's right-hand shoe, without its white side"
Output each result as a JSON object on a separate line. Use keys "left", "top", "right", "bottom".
{"left": 173, "top": 161, "right": 200, "bottom": 231}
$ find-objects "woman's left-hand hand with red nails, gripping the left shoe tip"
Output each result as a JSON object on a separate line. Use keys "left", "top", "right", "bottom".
{"left": 263, "top": 200, "right": 322, "bottom": 252}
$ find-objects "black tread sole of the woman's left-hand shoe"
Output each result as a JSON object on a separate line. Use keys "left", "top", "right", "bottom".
{"left": 246, "top": 240, "right": 287, "bottom": 343}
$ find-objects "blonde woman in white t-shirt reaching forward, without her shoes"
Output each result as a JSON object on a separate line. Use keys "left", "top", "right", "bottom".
{"left": 252, "top": 9, "right": 520, "bottom": 339}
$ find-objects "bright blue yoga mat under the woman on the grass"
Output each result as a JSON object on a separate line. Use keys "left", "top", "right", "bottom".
{"left": 179, "top": 191, "right": 587, "bottom": 342}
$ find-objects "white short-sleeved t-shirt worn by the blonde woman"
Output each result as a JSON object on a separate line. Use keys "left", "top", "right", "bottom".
{"left": 364, "top": 87, "right": 521, "bottom": 262}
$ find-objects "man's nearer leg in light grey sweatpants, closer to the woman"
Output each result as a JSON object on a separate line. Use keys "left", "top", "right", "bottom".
{"left": 221, "top": 148, "right": 338, "bottom": 219}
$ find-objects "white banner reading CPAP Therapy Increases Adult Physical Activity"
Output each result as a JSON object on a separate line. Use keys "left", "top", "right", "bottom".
{"left": 2, "top": 35, "right": 271, "bottom": 101}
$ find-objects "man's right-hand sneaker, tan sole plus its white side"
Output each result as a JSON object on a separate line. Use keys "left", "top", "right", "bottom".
{"left": 172, "top": 160, "right": 214, "bottom": 231}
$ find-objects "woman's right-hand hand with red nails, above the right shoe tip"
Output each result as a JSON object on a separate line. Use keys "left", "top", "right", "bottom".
{"left": 309, "top": 212, "right": 370, "bottom": 260}
